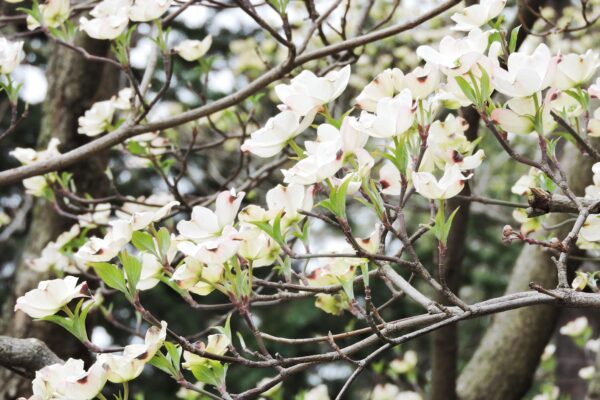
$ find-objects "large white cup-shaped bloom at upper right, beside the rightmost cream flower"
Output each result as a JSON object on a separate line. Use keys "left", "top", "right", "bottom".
{"left": 492, "top": 43, "right": 560, "bottom": 97}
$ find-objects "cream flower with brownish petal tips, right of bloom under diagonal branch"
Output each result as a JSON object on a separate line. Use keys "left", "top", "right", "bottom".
{"left": 356, "top": 68, "right": 406, "bottom": 112}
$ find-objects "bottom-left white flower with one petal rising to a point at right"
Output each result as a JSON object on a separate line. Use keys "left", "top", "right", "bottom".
{"left": 97, "top": 321, "right": 167, "bottom": 383}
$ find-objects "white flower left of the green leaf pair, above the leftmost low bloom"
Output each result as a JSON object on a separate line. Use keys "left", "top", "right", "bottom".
{"left": 75, "top": 219, "right": 133, "bottom": 262}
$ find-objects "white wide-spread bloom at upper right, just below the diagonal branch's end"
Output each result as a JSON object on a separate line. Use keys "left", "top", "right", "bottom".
{"left": 417, "top": 28, "right": 488, "bottom": 76}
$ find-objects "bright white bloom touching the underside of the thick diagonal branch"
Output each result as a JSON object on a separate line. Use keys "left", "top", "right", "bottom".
{"left": 275, "top": 65, "right": 350, "bottom": 116}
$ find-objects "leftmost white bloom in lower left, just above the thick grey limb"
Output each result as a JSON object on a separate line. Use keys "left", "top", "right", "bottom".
{"left": 15, "top": 276, "right": 87, "bottom": 318}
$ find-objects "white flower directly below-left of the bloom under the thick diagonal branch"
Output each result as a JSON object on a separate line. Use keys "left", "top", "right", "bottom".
{"left": 241, "top": 110, "right": 315, "bottom": 158}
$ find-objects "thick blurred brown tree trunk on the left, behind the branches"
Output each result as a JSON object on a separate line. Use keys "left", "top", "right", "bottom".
{"left": 0, "top": 37, "right": 118, "bottom": 399}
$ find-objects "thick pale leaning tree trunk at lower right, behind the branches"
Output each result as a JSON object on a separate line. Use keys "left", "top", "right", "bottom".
{"left": 457, "top": 145, "right": 593, "bottom": 400}
